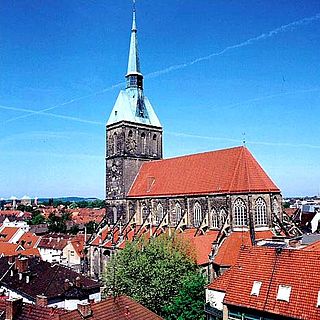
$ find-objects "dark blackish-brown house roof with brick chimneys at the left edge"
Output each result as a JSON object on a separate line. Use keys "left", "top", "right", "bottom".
{"left": 0, "top": 257, "right": 100, "bottom": 301}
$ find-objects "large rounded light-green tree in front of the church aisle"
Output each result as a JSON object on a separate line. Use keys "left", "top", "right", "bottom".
{"left": 104, "top": 235, "right": 203, "bottom": 319}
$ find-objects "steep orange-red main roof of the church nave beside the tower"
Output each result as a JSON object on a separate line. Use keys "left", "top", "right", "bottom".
{"left": 128, "top": 147, "right": 280, "bottom": 197}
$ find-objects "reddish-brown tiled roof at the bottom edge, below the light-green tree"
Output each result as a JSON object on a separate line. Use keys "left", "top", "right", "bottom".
{"left": 60, "top": 296, "right": 162, "bottom": 320}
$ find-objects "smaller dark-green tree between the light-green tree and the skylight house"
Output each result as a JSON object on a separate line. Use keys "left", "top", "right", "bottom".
{"left": 163, "top": 273, "right": 206, "bottom": 320}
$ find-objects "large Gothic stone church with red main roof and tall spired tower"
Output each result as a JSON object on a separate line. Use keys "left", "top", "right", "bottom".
{"left": 88, "top": 9, "right": 294, "bottom": 278}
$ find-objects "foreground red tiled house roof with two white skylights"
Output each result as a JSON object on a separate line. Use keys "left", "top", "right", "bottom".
{"left": 220, "top": 247, "right": 320, "bottom": 320}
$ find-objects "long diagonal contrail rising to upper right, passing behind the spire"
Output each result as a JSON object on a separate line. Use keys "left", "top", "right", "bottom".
{"left": 5, "top": 13, "right": 320, "bottom": 122}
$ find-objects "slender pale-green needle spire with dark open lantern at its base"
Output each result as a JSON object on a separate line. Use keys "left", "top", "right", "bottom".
{"left": 126, "top": 1, "right": 143, "bottom": 89}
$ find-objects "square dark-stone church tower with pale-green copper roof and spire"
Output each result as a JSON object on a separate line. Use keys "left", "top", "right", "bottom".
{"left": 106, "top": 7, "right": 162, "bottom": 224}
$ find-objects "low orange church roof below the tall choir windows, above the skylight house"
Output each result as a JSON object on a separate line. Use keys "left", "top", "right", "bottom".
{"left": 213, "top": 230, "right": 274, "bottom": 267}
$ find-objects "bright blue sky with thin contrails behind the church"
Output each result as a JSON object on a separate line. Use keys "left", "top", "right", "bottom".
{"left": 0, "top": 0, "right": 320, "bottom": 198}
